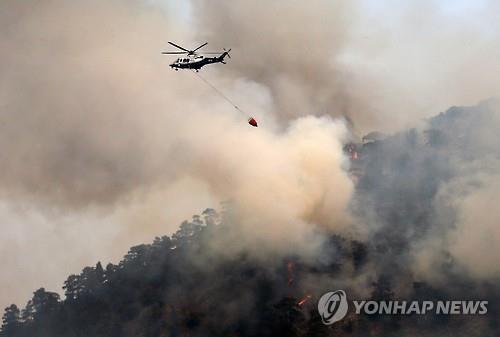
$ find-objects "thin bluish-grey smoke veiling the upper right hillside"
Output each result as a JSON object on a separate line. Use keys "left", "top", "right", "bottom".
{"left": 352, "top": 100, "right": 500, "bottom": 291}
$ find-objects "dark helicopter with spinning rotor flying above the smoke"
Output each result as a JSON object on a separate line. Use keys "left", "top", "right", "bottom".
{"left": 162, "top": 41, "right": 231, "bottom": 72}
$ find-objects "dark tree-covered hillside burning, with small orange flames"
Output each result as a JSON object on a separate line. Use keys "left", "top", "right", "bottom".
{"left": 1, "top": 101, "right": 500, "bottom": 337}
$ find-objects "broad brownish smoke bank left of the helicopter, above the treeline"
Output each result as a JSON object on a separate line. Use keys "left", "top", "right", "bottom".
{"left": 0, "top": 1, "right": 200, "bottom": 305}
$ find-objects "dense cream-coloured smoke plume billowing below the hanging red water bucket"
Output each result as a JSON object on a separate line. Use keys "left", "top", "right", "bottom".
{"left": 178, "top": 117, "right": 352, "bottom": 255}
